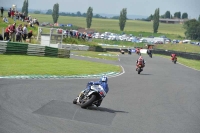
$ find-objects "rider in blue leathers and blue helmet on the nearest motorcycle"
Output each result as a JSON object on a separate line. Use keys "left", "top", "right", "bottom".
{"left": 78, "top": 76, "right": 109, "bottom": 106}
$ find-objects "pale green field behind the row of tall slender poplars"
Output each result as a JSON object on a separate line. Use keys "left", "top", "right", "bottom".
{"left": 27, "top": 14, "right": 184, "bottom": 36}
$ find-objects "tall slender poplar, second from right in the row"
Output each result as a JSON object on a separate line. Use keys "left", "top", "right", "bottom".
{"left": 119, "top": 8, "right": 127, "bottom": 31}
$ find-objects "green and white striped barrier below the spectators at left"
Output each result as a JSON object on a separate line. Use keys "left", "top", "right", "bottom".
{"left": 0, "top": 41, "right": 70, "bottom": 58}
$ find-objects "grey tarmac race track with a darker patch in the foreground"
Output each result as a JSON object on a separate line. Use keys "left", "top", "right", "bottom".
{"left": 0, "top": 54, "right": 200, "bottom": 133}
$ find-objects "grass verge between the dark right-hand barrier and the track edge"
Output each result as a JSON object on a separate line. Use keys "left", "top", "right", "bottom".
{"left": 154, "top": 54, "right": 200, "bottom": 70}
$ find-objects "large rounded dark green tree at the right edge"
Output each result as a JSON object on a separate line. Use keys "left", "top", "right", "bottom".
{"left": 183, "top": 19, "right": 200, "bottom": 40}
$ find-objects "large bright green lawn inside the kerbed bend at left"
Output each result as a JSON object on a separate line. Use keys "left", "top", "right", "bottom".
{"left": 0, "top": 55, "right": 121, "bottom": 76}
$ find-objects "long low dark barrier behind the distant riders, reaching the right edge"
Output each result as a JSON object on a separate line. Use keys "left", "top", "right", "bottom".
{"left": 105, "top": 48, "right": 200, "bottom": 60}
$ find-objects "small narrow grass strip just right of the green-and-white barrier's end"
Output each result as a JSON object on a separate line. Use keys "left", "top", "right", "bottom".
{"left": 72, "top": 51, "right": 118, "bottom": 61}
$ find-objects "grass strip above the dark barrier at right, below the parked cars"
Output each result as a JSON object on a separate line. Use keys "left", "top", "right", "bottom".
{"left": 154, "top": 44, "right": 200, "bottom": 54}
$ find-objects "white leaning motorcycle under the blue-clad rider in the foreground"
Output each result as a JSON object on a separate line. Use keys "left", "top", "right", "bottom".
{"left": 73, "top": 84, "right": 106, "bottom": 108}
